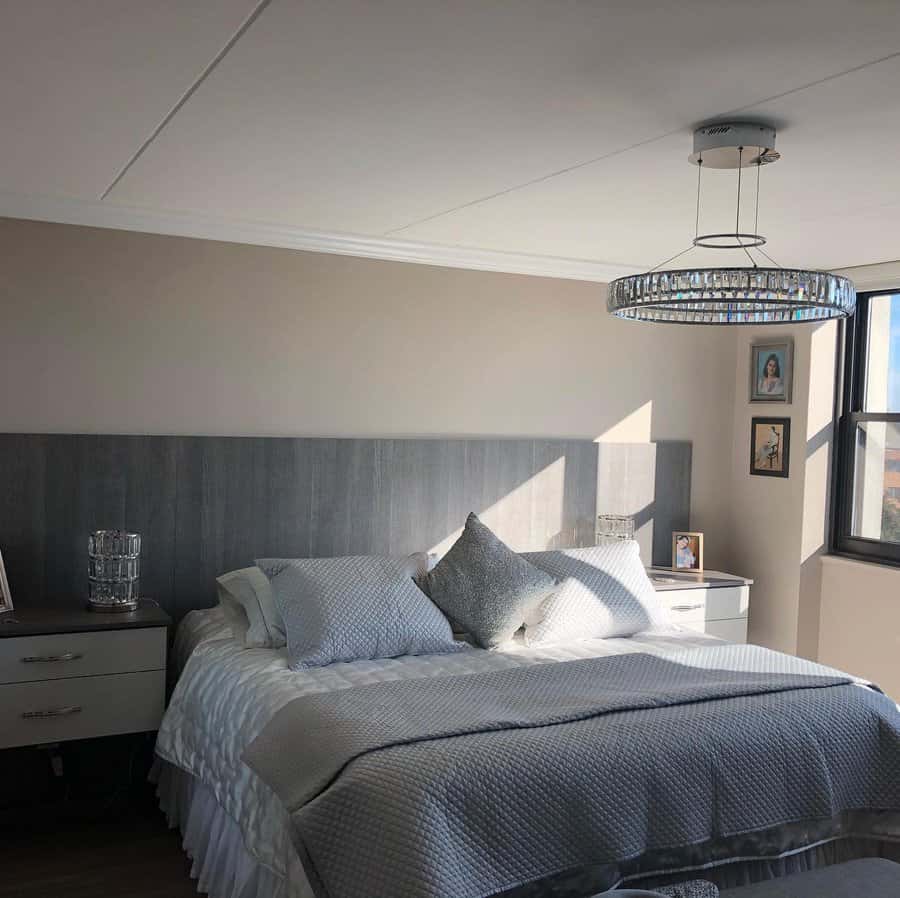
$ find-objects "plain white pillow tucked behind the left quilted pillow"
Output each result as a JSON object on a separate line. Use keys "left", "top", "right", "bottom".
{"left": 216, "top": 567, "right": 287, "bottom": 649}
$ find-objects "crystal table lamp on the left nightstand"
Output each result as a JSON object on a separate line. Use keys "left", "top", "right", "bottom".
{"left": 88, "top": 530, "right": 141, "bottom": 611}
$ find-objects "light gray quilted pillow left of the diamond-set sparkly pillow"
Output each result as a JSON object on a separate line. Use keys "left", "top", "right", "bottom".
{"left": 259, "top": 554, "right": 468, "bottom": 670}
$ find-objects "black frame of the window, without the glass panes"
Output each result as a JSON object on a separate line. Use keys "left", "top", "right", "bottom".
{"left": 831, "top": 286, "right": 900, "bottom": 567}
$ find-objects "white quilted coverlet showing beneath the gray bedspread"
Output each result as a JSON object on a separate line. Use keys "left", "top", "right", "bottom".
{"left": 156, "top": 609, "right": 719, "bottom": 880}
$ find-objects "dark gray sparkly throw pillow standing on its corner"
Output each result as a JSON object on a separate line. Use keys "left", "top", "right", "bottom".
{"left": 422, "top": 514, "right": 556, "bottom": 648}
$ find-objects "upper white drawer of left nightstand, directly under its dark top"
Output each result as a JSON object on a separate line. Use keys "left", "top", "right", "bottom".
{"left": 0, "top": 627, "right": 166, "bottom": 684}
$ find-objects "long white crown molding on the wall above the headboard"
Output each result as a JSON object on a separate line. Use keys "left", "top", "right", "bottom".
{"left": 0, "top": 191, "right": 635, "bottom": 283}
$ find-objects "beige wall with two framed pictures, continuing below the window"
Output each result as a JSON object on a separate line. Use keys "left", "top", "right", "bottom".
{"left": 726, "top": 266, "right": 900, "bottom": 697}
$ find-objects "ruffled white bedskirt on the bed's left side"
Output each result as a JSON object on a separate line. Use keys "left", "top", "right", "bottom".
{"left": 150, "top": 759, "right": 312, "bottom": 898}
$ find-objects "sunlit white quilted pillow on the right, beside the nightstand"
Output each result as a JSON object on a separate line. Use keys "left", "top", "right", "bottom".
{"left": 523, "top": 539, "right": 671, "bottom": 645}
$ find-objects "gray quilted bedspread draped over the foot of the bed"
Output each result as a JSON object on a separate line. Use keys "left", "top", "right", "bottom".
{"left": 244, "top": 646, "right": 900, "bottom": 898}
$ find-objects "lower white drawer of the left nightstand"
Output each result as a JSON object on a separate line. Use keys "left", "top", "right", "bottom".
{"left": 0, "top": 670, "right": 166, "bottom": 748}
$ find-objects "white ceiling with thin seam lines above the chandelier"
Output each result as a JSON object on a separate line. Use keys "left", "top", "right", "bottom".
{"left": 0, "top": 0, "right": 900, "bottom": 279}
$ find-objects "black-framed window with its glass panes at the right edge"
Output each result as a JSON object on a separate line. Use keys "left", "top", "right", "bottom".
{"left": 834, "top": 289, "right": 900, "bottom": 564}
